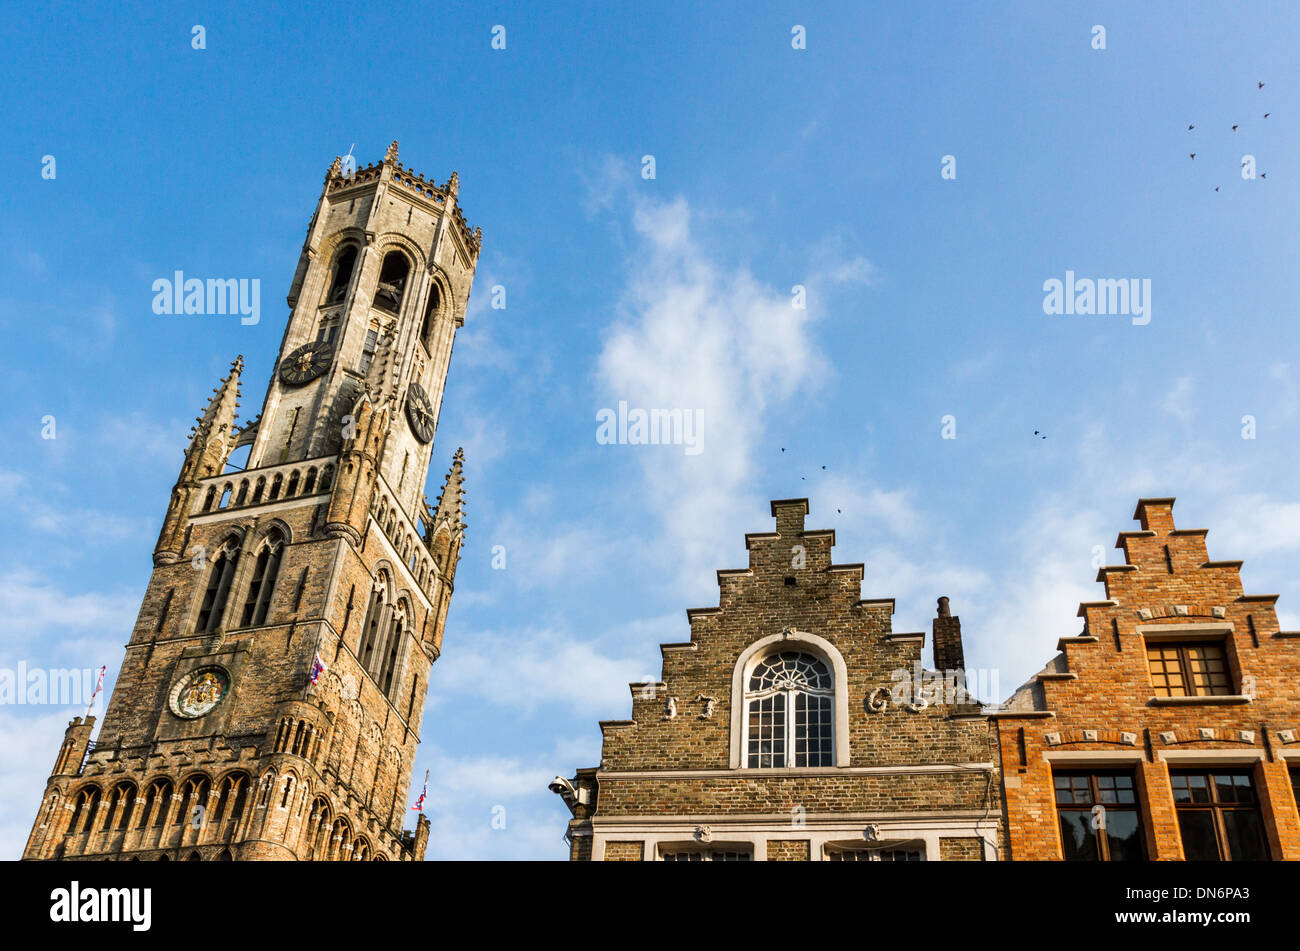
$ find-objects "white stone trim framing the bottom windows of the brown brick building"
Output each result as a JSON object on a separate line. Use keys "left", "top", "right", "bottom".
{"left": 592, "top": 815, "right": 997, "bottom": 861}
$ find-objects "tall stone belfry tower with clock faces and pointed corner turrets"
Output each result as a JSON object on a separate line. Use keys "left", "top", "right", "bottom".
{"left": 23, "top": 142, "right": 482, "bottom": 860}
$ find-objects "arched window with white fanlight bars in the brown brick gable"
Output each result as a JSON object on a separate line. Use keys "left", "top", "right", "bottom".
{"left": 745, "top": 651, "right": 835, "bottom": 769}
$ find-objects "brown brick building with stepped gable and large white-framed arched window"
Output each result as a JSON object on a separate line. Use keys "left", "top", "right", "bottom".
{"left": 551, "top": 499, "right": 1002, "bottom": 861}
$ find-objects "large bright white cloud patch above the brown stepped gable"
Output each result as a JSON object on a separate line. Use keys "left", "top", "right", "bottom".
{"left": 597, "top": 197, "right": 872, "bottom": 591}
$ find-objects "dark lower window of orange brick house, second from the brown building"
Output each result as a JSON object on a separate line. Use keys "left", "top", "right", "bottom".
{"left": 1170, "top": 769, "right": 1269, "bottom": 861}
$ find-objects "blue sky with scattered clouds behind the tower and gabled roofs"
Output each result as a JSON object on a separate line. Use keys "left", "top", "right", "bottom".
{"left": 0, "top": 3, "right": 1300, "bottom": 859}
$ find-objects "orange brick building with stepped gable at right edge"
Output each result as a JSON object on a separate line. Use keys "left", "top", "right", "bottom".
{"left": 991, "top": 499, "right": 1300, "bottom": 860}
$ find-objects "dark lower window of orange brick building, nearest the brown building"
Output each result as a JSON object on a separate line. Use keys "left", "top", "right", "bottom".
{"left": 1052, "top": 772, "right": 1144, "bottom": 861}
